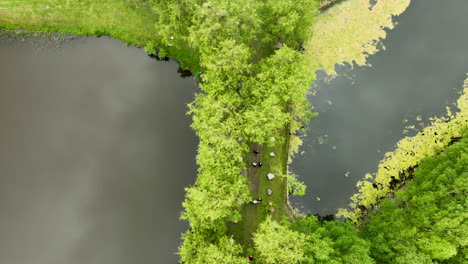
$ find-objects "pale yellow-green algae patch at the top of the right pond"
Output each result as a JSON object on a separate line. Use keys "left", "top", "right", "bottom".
{"left": 305, "top": 0, "right": 410, "bottom": 76}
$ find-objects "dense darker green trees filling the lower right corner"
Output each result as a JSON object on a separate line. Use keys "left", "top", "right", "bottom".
{"left": 362, "top": 136, "right": 468, "bottom": 264}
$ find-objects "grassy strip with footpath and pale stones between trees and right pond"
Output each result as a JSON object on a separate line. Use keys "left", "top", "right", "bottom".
{"left": 228, "top": 128, "right": 291, "bottom": 254}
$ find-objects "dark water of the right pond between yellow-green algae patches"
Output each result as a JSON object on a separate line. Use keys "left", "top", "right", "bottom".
{"left": 290, "top": 0, "right": 468, "bottom": 215}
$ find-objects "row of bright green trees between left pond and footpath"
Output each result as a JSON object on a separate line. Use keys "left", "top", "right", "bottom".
{"left": 182, "top": 94, "right": 250, "bottom": 228}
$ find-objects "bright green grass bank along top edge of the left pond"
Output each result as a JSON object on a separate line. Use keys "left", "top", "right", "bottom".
{"left": 0, "top": 0, "right": 156, "bottom": 46}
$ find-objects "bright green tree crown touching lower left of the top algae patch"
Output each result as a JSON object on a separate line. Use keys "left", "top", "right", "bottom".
{"left": 243, "top": 46, "right": 314, "bottom": 143}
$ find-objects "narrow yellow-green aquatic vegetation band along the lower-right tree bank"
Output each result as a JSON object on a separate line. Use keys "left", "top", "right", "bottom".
{"left": 338, "top": 75, "right": 468, "bottom": 222}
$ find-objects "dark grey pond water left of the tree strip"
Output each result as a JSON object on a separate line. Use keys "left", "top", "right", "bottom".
{"left": 0, "top": 37, "right": 197, "bottom": 264}
